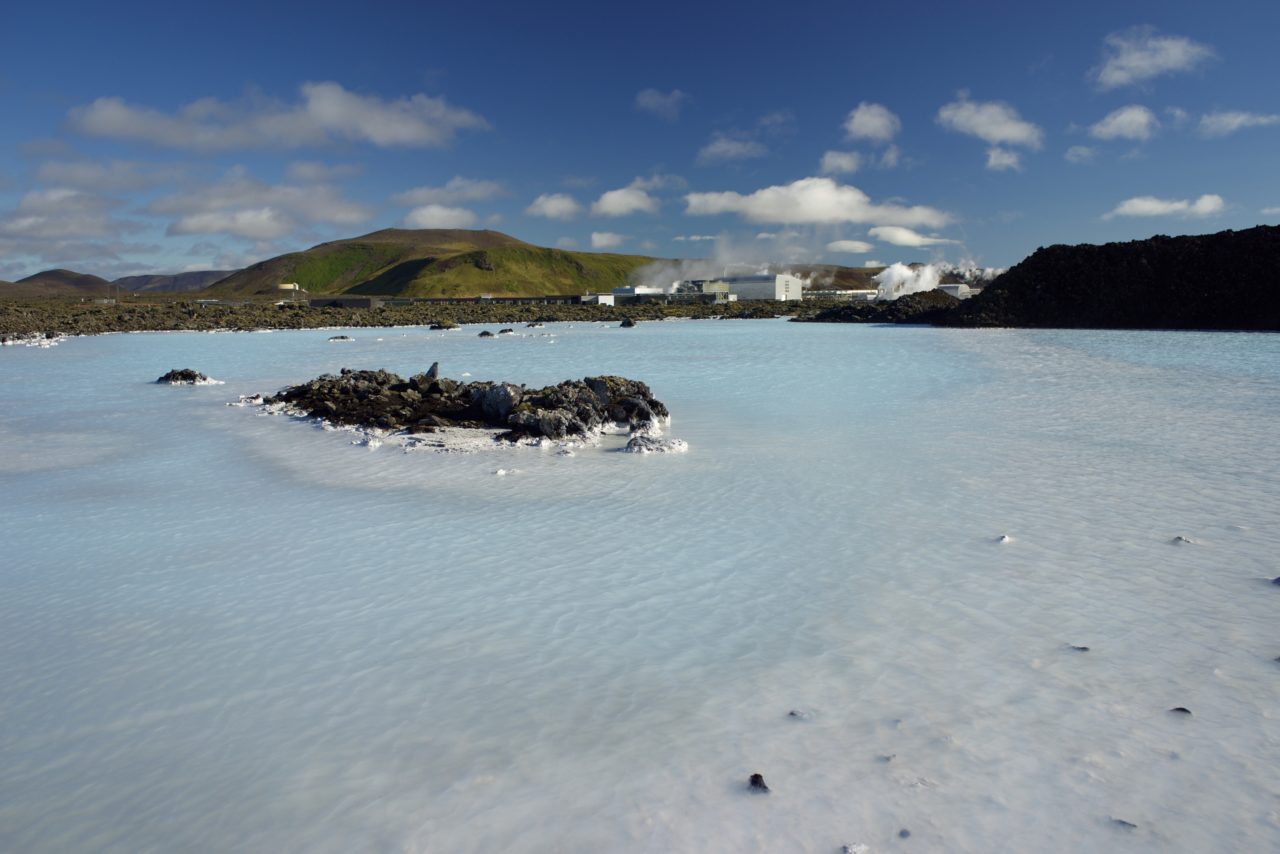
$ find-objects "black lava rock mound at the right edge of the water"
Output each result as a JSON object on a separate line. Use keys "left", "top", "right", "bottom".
{"left": 945, "top": 225, "right": 1280, "bottom": 330}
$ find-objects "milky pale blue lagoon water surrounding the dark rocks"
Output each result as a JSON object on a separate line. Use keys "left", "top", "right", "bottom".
{"left": 0, "top": 321, "right": 1280, "bottom": 853}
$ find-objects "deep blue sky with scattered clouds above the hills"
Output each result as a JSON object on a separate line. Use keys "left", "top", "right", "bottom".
{"left": 0, "top": 1, "right": 1280, "bottom": 279}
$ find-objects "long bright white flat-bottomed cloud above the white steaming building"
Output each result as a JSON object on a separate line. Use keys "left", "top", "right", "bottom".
{"left": 685, "top": 178, "right": 951, "bottom": 228}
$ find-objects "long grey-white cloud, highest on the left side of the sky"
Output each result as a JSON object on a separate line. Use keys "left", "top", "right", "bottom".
{"left": 68, "top": 82, "right": 489, "bottom": 151}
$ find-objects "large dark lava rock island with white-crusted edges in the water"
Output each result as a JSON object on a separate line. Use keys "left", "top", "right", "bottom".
{"left": 262, "top": 366, "right": 668, "bottom": 442}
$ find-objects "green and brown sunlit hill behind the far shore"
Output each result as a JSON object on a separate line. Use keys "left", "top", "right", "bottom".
{"left": 207, "top": 228, "right": 653, "bottom": 297}
